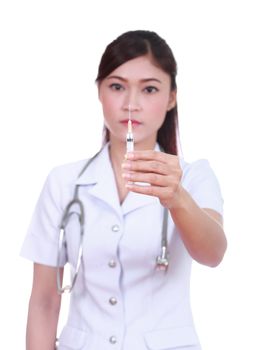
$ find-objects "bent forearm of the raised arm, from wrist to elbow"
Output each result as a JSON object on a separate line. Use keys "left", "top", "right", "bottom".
{"left": 170, "top": 187, "right": 227, "bottom": 267}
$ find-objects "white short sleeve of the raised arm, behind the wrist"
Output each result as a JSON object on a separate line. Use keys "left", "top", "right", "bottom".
{"left": 182, "top": 159, "right": 223, "bottom": 215}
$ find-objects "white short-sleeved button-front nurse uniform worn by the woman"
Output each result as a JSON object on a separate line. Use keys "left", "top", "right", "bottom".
{"left": 21, "top": 145, "right": 223, "bottom": 350}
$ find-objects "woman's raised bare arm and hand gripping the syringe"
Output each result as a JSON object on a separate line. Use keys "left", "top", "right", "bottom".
{"left": 122, "top": 151, "right": 227, "bottom": 266}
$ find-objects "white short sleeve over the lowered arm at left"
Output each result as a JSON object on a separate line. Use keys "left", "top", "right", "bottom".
{"left": 21, "top": 170, "right": 66, "bottom": 266}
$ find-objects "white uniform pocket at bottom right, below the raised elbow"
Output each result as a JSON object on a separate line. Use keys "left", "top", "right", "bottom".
{"left": 144, "top": 327, "right": 201, "bottom": 350}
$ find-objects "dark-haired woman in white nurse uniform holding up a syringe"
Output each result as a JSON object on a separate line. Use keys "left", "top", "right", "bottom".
{"left": 22, "top": 30, "right": 227, "bottom": 350}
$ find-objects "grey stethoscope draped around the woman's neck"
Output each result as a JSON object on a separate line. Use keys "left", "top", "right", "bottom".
{"left": 57, "top": 151, "right": 169, "bottom": 294}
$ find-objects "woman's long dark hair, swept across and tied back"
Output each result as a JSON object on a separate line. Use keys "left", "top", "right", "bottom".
{"left": 96, "top": 30, "right": 178, "bottom": 155}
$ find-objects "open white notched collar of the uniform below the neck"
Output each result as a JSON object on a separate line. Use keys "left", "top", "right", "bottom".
{"left": 76, "top": 143, "right": 159, "bottom": 216}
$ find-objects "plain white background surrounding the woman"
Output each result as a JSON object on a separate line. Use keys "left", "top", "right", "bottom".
{"left": 0, "top": 0, "right": 259, "bottom": 350}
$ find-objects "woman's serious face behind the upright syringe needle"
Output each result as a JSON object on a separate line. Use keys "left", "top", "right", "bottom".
{"left": 99, "top": 56, "right": 176, "bottom": 147}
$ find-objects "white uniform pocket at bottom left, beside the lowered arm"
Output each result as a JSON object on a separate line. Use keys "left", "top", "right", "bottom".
{"left": 57, "top": 326, "right": 89, "bottom": 350}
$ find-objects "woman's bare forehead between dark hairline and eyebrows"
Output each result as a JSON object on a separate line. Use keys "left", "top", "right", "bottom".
{"left": 107, "top": 56, "right": 170, "bottom": 80}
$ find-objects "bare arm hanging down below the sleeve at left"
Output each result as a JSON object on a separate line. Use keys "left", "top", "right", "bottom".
{"left": 26, "top": 264, "right": 61, "bottom": 350}
